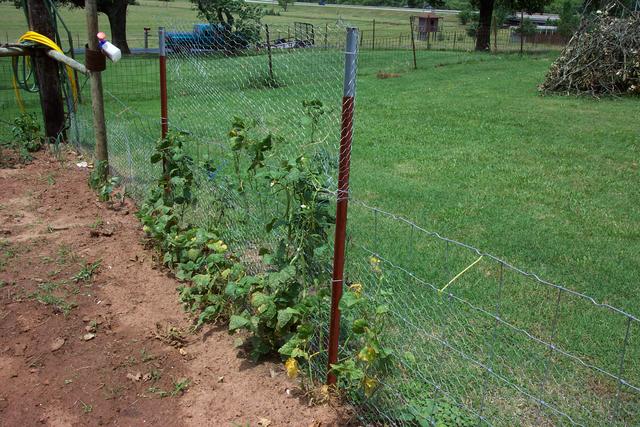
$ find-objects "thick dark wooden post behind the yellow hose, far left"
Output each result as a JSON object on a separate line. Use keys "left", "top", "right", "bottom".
{"left": 26, "top": 0, "right": 66, "bottom": 143}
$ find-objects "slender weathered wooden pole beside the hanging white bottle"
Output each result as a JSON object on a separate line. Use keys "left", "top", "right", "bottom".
{"left": 84, "top": 0, "right": 109, "bottom": 179}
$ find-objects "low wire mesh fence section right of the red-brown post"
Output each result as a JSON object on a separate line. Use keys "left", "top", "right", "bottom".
{"left": 340, "top": 199, "right": 640, "bottom": 426}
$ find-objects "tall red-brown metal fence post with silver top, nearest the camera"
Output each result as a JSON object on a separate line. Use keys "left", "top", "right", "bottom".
{"left": 327, "top": 27, "right": 358, "bottom": 384}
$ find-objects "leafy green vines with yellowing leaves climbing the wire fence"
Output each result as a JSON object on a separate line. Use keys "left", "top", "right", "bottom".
{"left": 138, "top": 113, "right": 391, "bottom": 402}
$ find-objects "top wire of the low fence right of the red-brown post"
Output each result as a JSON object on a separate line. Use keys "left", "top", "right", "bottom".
{"left": 350, "top": 198, "right": 640, "bottom": 323}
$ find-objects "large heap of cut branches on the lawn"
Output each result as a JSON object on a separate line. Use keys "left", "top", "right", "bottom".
{"left": 540, "top": 10, "right": 640, "bottom": 97}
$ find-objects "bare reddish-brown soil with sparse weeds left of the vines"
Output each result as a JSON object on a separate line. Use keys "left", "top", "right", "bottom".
{"left": 0, "top": 154, "right": 346, "bottom": 427}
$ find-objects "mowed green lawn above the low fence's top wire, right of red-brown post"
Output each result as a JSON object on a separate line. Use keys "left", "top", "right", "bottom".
{"left": 352, "top": 53, "right": 640, "bottom": 315}
